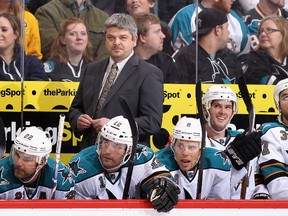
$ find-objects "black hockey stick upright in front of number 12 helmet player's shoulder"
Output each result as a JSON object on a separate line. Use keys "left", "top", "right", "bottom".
{"left": 119, "top": 97, "right": 138, "bottom": 199}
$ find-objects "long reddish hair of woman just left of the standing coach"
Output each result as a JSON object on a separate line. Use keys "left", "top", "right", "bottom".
{"left": 50, "top": 17, "right": 93, "bottom": 63}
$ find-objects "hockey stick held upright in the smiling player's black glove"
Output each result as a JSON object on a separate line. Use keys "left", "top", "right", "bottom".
{"left": 238, "top": 76, "right": 255, "bottom": 199}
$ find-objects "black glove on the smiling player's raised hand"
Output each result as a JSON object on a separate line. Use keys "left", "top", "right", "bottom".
{"left": 224, "top": 131, "right": 262, "bottom": 170}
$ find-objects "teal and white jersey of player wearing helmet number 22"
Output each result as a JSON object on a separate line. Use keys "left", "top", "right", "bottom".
{"left": 0, "top": 157, "right": 75, "bottom": 200}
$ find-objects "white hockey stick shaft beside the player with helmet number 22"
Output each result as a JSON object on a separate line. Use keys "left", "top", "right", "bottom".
{"left": 51, "top": 114, "right": 65, "bottom": 199}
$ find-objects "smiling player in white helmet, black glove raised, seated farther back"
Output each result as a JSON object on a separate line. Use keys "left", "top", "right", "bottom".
{"left": 203, "top": 85, "right": 261, "bottom": 199}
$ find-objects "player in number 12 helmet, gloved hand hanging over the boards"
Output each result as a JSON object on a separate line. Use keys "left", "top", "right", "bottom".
{"left": 69, "top": 116, "right": 179, "bottom": 212}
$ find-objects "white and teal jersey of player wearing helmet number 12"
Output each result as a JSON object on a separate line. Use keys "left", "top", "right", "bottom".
{"left": 69, "top": 145, "right": 171, "bottom": 199}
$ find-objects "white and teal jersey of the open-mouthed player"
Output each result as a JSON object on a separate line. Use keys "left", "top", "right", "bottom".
{"left": 156, "top": 146, "right": 231, "bottom": 199}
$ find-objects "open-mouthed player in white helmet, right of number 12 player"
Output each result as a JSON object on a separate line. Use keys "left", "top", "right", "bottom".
{"left": 156, "top": 116, "right": 230, "bottom": 199}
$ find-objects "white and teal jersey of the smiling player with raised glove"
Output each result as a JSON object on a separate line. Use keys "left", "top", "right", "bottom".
{"left": 206, "top": 130, "right": 257, "bottom": 199}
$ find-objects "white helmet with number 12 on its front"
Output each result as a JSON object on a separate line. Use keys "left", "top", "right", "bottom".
{"left": 96, "top": 116, "right": 133, "bottom": 170}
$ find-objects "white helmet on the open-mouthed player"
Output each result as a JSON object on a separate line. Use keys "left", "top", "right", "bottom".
{"left": 171, "top": 116, "right": 202, "bottom": 146}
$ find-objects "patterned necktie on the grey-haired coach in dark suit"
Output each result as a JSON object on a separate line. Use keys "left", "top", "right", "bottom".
{"left": 96, "top": 63, "right": 118, "bottom": 113}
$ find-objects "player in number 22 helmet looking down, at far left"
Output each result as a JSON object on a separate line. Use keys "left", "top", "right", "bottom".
{"left": 0, "top": 126, "right": 75, "bottom": 199}
